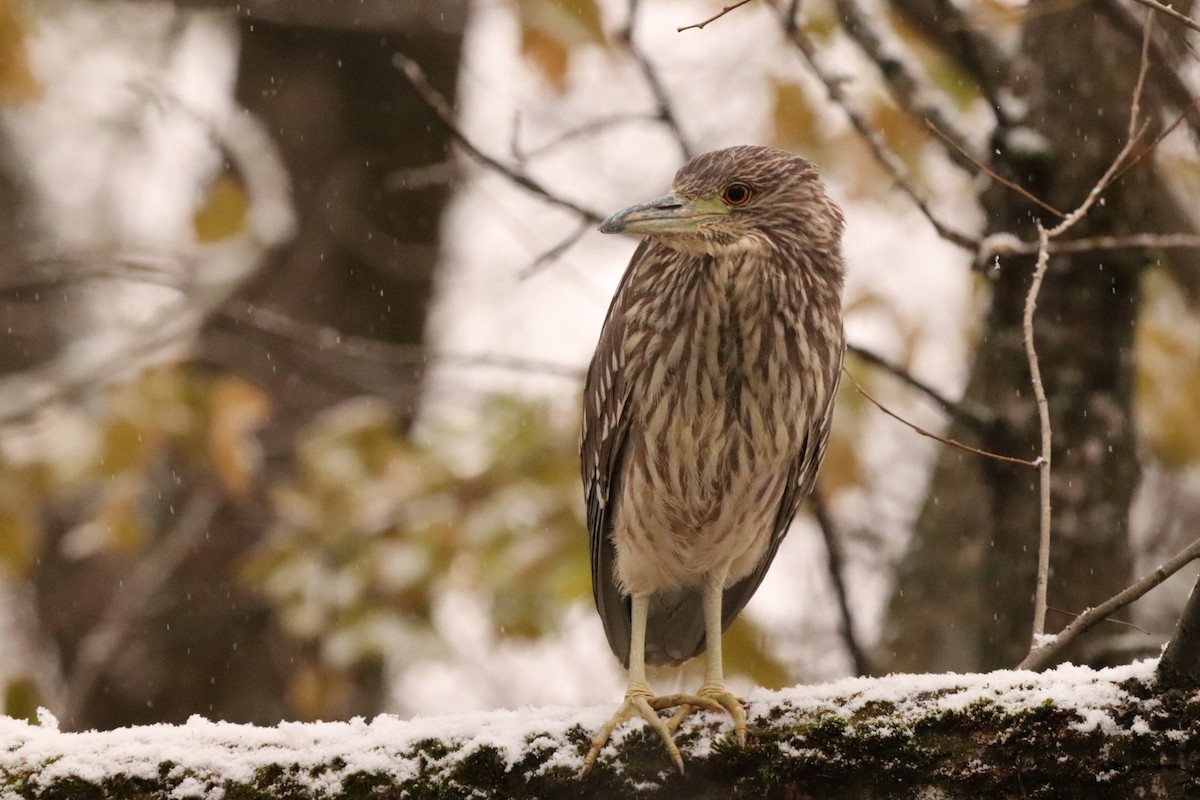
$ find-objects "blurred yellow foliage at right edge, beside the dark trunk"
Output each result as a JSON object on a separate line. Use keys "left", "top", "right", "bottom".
{"left": 1135, "top": 269, "right": 1200, "bottom": 468}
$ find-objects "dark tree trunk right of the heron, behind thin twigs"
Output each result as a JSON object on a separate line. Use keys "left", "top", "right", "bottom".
{"left": 881, "top": 0, "right": 1163, "bottom": 670}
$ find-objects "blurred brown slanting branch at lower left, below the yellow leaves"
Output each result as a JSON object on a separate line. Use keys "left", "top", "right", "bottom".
{"left": 64, "top": 487, "right": 221, "bottom": 721}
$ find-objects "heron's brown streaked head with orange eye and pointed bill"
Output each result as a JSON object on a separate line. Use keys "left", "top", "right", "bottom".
{"left": 600, "top": 145, "right": 845, "bottom": 257}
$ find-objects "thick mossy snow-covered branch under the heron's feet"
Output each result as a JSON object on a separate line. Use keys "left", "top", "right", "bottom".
{"left": 0, "top": 661, "right": 1200, "bottom": 800}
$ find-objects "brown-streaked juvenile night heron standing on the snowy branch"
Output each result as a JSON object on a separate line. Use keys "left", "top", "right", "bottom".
{"left": 580, "top": 146, "right": 845, "bottom": 775}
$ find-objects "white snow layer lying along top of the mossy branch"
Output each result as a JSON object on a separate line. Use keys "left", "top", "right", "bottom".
{"left": 0, "top": 660, "right": 1186, "bottom": 800}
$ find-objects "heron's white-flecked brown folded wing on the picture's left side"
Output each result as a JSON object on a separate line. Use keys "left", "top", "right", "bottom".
{"left": 580, "top": 241, "right": 648, "bottom": 666}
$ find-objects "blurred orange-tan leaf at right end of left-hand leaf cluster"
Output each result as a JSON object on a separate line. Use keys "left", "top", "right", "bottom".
{"left": 208, "top": 375, "right": 270, "bottom": 497}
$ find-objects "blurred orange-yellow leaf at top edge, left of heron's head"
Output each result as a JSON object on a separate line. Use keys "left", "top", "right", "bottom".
{"left": 515, "top": 0, "right": 607, "bottom": 91}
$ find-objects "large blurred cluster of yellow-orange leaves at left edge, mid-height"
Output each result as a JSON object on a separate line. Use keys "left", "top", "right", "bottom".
{"left": 0, "top": 366, "right": 265, "bottom": 577}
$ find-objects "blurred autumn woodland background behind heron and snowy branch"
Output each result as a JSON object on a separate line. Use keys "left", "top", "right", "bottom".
{"left": 0, "top": 0, "right": 1200, "bottom": 729}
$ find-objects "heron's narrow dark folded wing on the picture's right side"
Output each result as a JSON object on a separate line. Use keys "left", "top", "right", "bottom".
{"left": 715, "top": 342, "right": 846, "bottom": 633}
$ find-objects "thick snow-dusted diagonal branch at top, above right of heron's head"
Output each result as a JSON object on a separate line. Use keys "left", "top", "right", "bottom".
{"left": 834, "top": 0, "right": 978, "bottom": 172}
